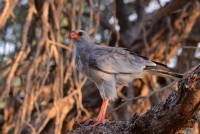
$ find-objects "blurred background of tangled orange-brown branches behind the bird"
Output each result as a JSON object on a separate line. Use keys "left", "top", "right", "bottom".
{"left": 0, "top": 0, "right": 200, "bottom": 134}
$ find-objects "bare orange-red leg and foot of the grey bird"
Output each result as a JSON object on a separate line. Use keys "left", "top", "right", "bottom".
{"left": 94, "top": 99, "right": 109, "bottom": 126}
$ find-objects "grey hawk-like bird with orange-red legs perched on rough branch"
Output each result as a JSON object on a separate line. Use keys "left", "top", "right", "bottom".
{"left": 68, "top": 29, "right": 183, "bottom": 126}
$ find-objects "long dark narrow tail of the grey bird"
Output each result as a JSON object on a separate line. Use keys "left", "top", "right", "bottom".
{"left": 144, "top": 62, "right": 184, "bottom": 79}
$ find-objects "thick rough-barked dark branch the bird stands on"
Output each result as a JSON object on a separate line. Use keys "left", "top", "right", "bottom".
{"left": 70, "top": 65, "right": 200, "bottom": 134}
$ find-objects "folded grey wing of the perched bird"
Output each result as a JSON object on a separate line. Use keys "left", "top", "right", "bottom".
{"left": 89, "top": 47, "right": 156, "bottom": 74}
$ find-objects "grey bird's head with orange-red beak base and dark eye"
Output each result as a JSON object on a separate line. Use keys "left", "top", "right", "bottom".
{"left": 68, "top": 30, "right": 90, "bottom": 42}
